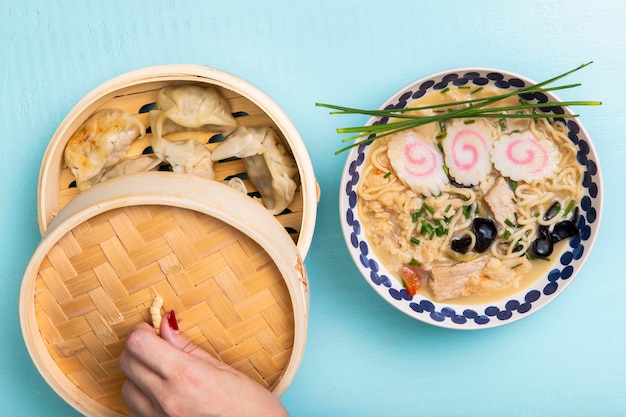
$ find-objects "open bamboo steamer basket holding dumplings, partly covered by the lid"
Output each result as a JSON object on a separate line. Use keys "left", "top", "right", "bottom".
{"left": 38, "top": 64, "right": 319, "bottom": 256}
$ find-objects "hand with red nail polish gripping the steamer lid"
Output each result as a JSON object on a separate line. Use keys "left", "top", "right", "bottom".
{"left": 120, "top": 312, "right": 288, "bottom": 417}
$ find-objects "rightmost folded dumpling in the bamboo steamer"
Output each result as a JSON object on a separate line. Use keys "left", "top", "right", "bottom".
{"left": 212, "top": 126, "right": 298, "bottom": 215}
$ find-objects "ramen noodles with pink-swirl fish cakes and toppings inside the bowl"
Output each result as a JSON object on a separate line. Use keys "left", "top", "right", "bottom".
{"left": 357, "top": 87, "right": 583, "bottom": 300}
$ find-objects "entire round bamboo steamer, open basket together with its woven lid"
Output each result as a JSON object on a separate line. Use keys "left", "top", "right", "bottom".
{"left": 20, "top": 65, "right": 319, "bottom": 417}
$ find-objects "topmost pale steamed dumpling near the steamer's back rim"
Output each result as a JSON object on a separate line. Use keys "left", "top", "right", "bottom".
{"left": 151, "top": 85, "right": 237, "bottom": 135}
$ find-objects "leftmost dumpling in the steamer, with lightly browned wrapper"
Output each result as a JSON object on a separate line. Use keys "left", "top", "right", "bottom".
{"left": 65, "top": 109, "right": 146, "bottom": 191}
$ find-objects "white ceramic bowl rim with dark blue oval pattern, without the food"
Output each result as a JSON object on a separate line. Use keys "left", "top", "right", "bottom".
{"left": 339, "top": 68, "right": 602, "bottom": 330}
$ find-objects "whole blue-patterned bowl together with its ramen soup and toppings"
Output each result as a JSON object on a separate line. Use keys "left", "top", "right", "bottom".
{"left": 339, "top": 68, "right": 602, "bottom": 329}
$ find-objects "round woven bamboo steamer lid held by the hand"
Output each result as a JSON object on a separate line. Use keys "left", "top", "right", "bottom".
{"left": 20, "top": 172, "right": 308, "bottom": 416}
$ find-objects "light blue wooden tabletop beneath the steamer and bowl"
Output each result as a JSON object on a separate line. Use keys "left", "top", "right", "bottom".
{"left": 0, "top": 0, "right": 626, "bottom": 417}
